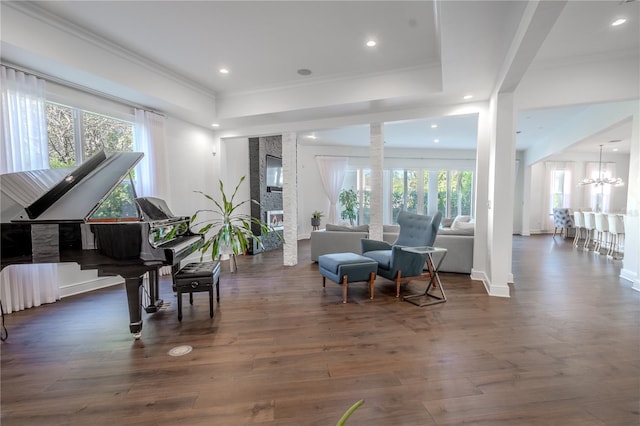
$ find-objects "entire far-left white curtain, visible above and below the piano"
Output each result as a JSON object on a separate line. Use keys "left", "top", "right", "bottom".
{"left": 0, "top": 67, "right": 60, "bottom": 313}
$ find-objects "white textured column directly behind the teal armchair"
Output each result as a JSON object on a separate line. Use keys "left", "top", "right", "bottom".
{"left": 369, "top": 123, "right": 384, "bottom": 240}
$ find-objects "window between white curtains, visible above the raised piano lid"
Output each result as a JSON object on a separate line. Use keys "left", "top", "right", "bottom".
{"left": 47, "top": 102, "right": 133, "bottom": 169}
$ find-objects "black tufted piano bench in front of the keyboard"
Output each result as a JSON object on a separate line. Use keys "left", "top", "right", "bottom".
{"left": 173, "top": 261, "right": 220, "bottom": 321}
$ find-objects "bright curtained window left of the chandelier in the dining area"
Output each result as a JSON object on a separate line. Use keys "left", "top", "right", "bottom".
{"left": 540, "top": 161, "right": 575, "bottom": 230}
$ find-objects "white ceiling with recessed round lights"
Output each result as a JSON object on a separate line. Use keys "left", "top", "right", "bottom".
{"left": 3, "top": 0, "right": 640, "bottom": 156}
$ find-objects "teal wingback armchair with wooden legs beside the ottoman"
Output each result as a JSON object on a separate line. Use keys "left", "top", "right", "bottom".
{"left": 360, "top": 211, "right": 442, "bottom": 297}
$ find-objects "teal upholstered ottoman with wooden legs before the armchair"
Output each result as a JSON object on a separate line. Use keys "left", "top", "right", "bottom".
{"left": 318, "top": 253, "right": 378, "bottom": 303}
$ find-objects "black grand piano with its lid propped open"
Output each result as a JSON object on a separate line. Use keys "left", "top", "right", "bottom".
{"left": 0, "top": 151, "right": 204, "bottom": 339}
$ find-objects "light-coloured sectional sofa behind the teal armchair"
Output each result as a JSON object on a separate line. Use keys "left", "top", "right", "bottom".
{"left": 311, "top": 218, "right": 474, "bottom": 274}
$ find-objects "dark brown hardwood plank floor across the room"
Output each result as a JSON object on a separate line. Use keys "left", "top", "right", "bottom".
{"left": 0, "top": 235, "right": 640, "bottom": 426}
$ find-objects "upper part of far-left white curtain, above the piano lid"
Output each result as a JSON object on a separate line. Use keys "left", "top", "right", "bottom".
{"left": 0, "top": 67, "right": 49, "bottom": 173}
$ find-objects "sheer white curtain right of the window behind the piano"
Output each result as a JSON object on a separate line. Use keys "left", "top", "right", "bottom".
{"left": 133, "top": 109, "right": 169, "bottom": 200}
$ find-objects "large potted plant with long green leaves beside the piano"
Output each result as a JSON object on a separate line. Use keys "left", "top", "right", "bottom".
{"left": 191, "top": 176, "right": 284, "bottom": 272}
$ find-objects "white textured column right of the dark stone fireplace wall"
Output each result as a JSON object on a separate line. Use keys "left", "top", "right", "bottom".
{"left": 282, "top": 132, "right": 298, "bottom": 266}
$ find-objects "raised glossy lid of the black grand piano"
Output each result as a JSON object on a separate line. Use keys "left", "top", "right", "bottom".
{"left": 3, "top": 151, "right": 144, "bottom": 223}
